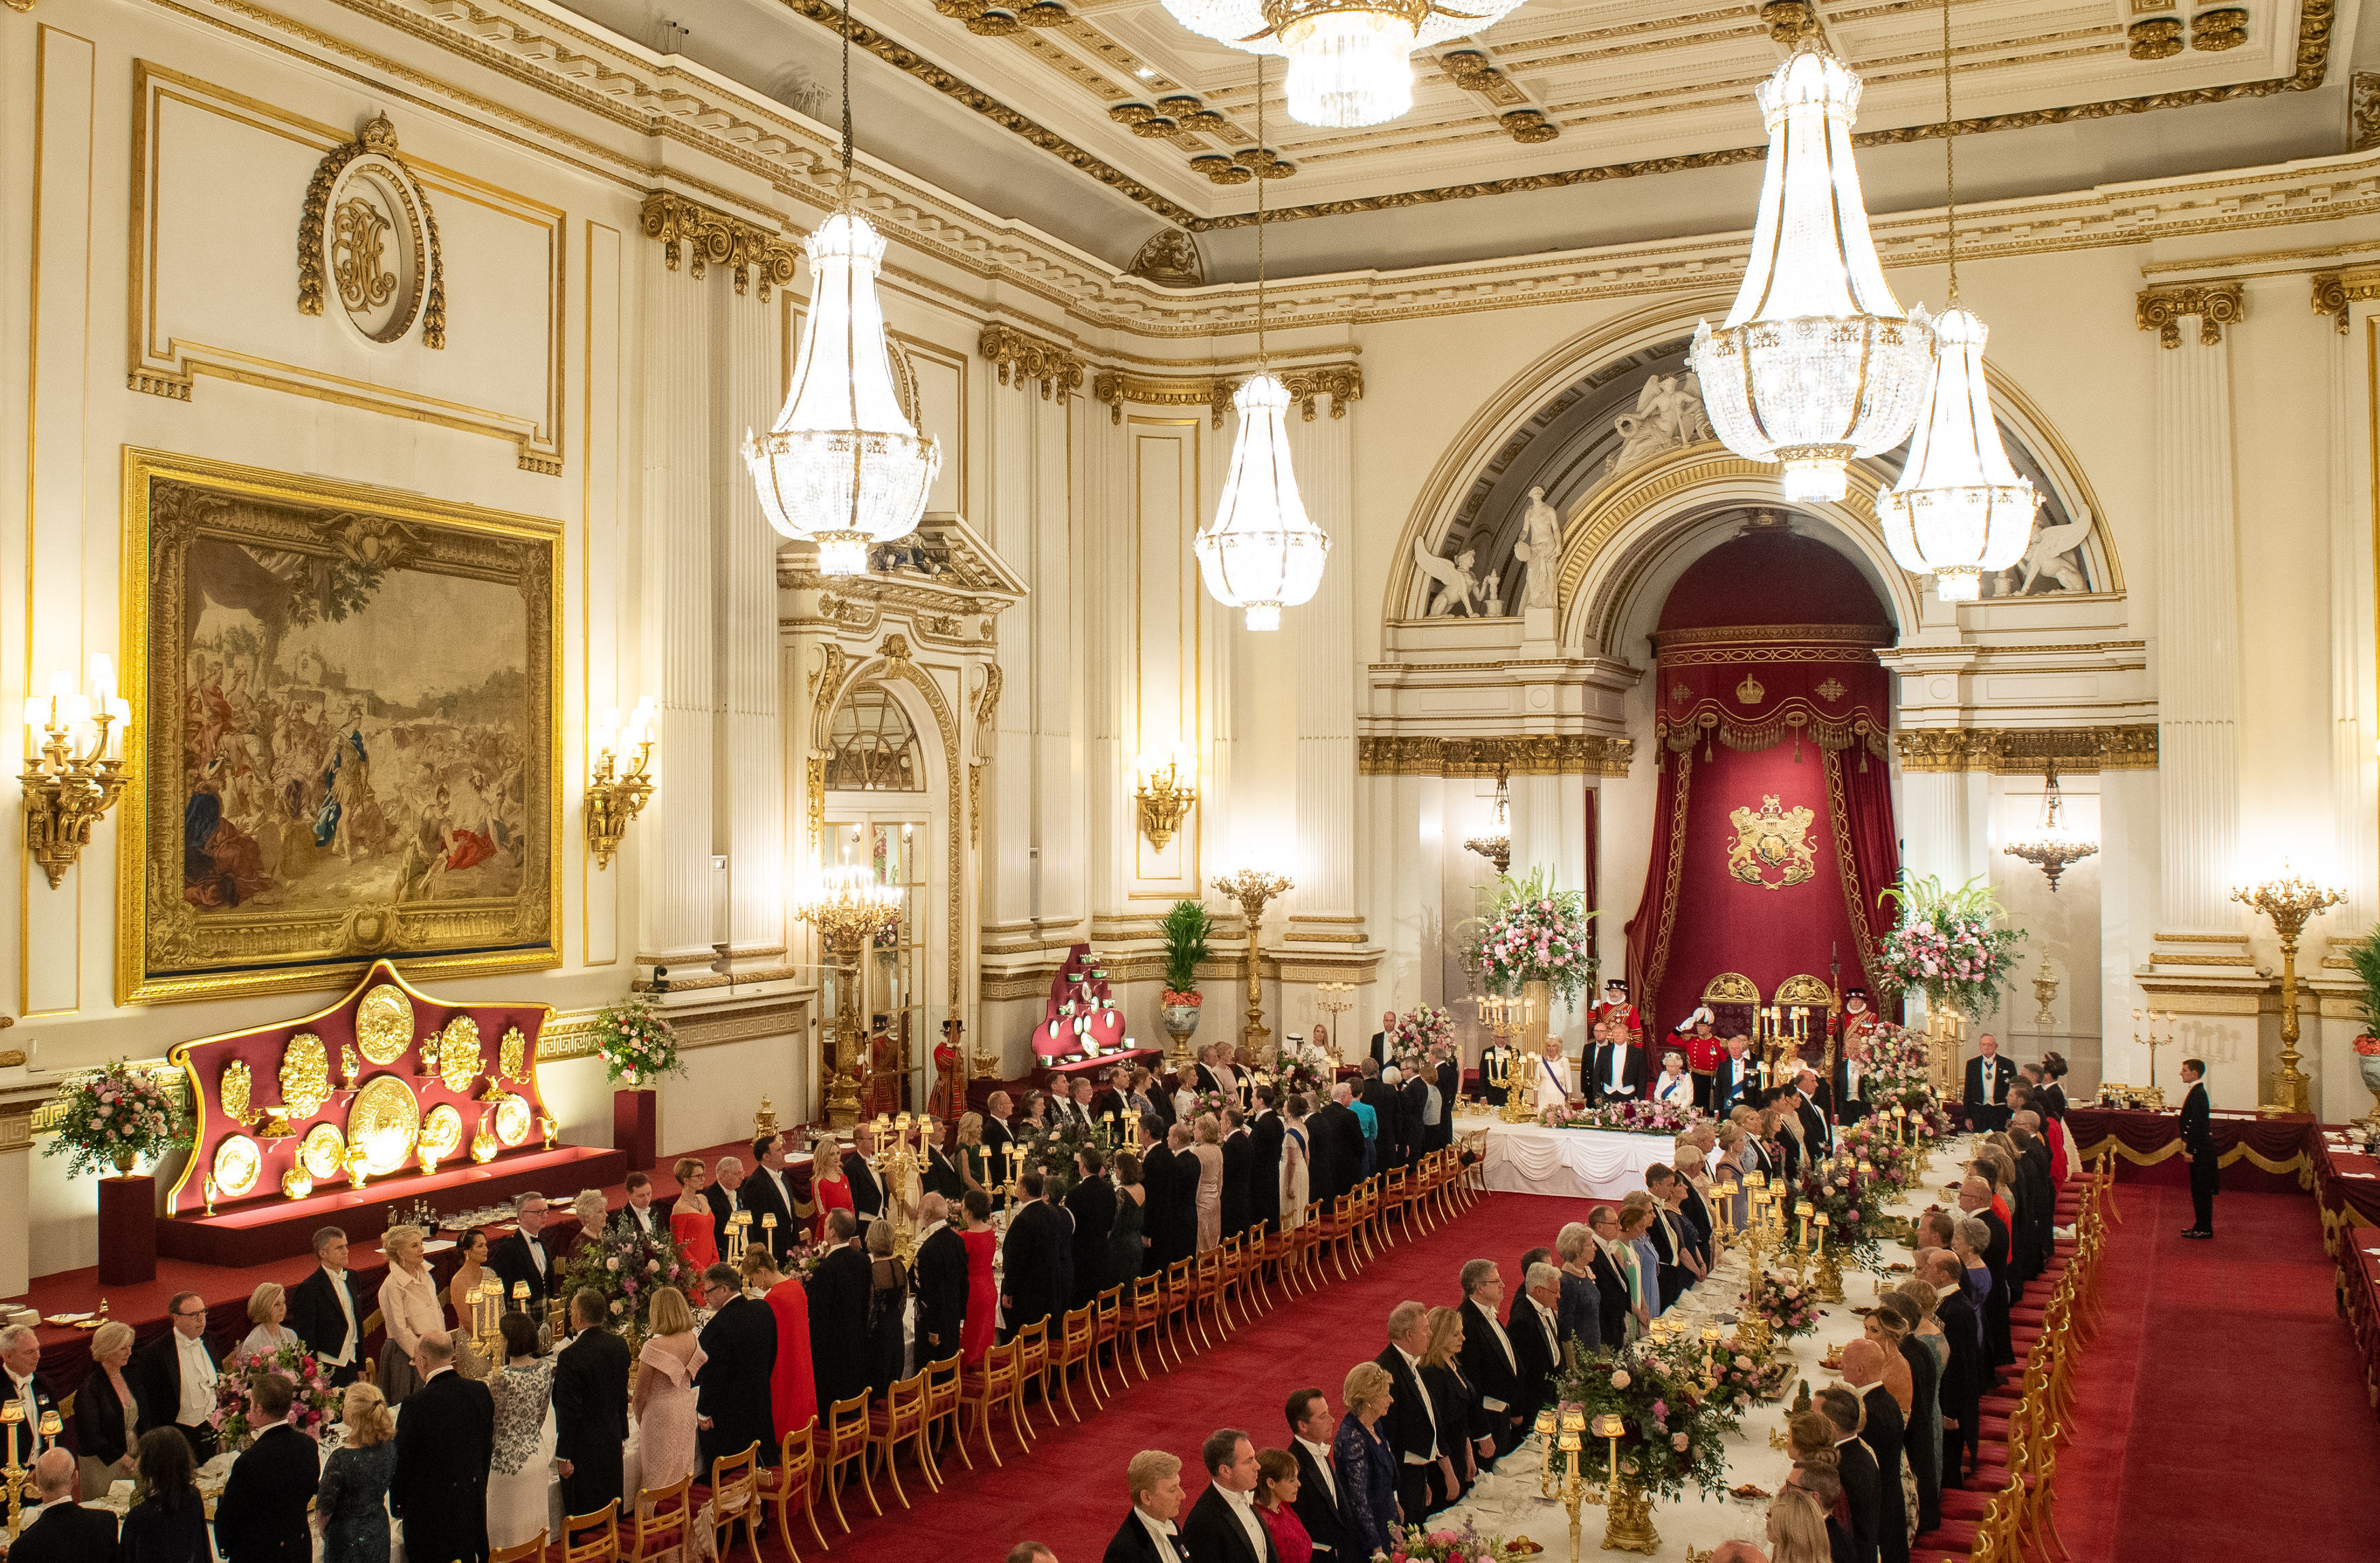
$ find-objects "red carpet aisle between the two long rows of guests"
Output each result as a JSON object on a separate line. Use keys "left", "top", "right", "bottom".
{"left": 804, "top": 1195, "right": 1590, "bottom": 1563}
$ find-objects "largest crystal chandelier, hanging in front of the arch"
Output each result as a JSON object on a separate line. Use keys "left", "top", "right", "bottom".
{"left": 1695, "top": 35, "right": 1933, "bottom": 500}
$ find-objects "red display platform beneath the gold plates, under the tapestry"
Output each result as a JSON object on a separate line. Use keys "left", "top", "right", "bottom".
{"left": 157, "top": 1144, "right": 628, "bottom": 1266}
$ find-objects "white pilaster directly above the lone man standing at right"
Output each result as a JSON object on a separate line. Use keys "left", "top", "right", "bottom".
{"left": 2154, "top": 321, "right": 2240, "bottom": 935}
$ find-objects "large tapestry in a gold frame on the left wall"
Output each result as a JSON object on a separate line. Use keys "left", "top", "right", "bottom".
{"left": 117, "top": 449, "right": 560, "bottom": 1001}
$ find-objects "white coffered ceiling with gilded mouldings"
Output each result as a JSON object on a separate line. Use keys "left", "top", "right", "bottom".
{"left": 552, "top": 0, "right": 2361, "bottom": 281}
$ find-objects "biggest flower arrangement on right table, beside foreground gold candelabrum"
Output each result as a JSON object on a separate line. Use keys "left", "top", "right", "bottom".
{"left": 1554, "top": 1339, "right": 1742, "bottom": 1499}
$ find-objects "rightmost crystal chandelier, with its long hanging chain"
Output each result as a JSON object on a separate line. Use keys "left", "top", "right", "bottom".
{"left": 1875, "top": 0, "right": 2059, "bottom": 597}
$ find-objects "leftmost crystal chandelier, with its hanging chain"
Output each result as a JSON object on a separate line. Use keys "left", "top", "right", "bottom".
{"left": 743, "top": 0, "right": 942, "bottom": 576}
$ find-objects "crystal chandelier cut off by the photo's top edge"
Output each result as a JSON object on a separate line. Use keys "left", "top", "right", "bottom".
{"left": 1164, "top": 0, "right": 1521, "bottom": 131}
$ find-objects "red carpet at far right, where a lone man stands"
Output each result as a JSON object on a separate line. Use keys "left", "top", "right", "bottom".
{"left": 2056, "top": 1182, "right": 2380, "bottom": 1563}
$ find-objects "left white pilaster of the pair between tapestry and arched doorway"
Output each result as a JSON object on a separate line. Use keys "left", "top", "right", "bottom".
{"left": 638, "top": 245, "right": 719, "bottom": 963}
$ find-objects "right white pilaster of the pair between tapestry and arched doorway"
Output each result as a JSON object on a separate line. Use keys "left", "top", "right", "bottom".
{"left": 704, "top": 286, "right": 790, "bottom": 963}
